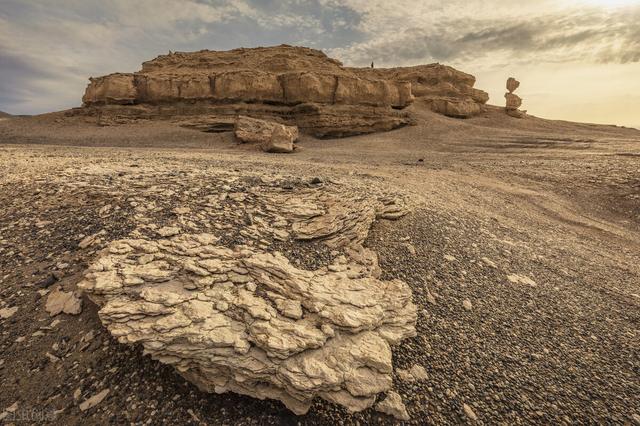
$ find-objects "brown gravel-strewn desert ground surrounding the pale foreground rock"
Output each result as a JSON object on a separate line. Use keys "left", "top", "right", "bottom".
{"left": 0, "top": 107, "right": 640, "bottom": 424}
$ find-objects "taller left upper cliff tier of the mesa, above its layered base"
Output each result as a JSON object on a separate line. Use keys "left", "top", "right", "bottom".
{"left": 83, "top": 46, "right": 413, "bottom": 108}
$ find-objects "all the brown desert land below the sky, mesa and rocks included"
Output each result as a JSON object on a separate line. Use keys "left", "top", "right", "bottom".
{"left": 0, "top": 45, "right": 640, "bottom": 425}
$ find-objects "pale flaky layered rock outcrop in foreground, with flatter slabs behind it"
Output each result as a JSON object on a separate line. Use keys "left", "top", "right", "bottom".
{"left": 79, "top": 178, "right": 417, "bottom": 414}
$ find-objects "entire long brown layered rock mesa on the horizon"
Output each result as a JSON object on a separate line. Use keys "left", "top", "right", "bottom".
{"left": 81, "top": 45, "right": 488, "bottom": 137}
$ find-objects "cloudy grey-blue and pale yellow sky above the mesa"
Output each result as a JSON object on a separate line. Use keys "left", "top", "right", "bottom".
{"left": 0, "top": 0, "right": 640, "bottom": 127}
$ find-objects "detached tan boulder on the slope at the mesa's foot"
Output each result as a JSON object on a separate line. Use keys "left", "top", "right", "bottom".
{"left": 235, "top": 116, "right": 298, "bottom": 153}
